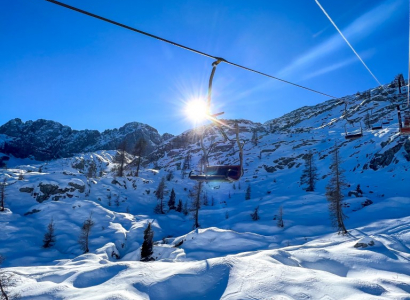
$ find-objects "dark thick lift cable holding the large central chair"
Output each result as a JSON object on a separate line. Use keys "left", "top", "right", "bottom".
{"left": 45, "top": 0, "right": 338, "bottom": 99}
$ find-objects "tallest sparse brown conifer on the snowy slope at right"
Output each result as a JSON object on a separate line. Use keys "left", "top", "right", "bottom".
{"left": 326, "top": 144, "right": 347, "bottom": 234}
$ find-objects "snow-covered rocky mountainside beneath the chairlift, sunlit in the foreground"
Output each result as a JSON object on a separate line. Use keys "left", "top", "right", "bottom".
{"left": 0, "top": 85, "right": 410, "bottom": 300}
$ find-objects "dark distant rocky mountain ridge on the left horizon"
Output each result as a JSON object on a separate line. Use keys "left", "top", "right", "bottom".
{"left": 0, "top": 119, "right": 172, "bottom": 160}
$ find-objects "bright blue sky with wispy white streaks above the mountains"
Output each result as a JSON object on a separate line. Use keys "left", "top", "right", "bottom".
{"left": 0, "top": 0, "right": 409, "bottom": 134}
